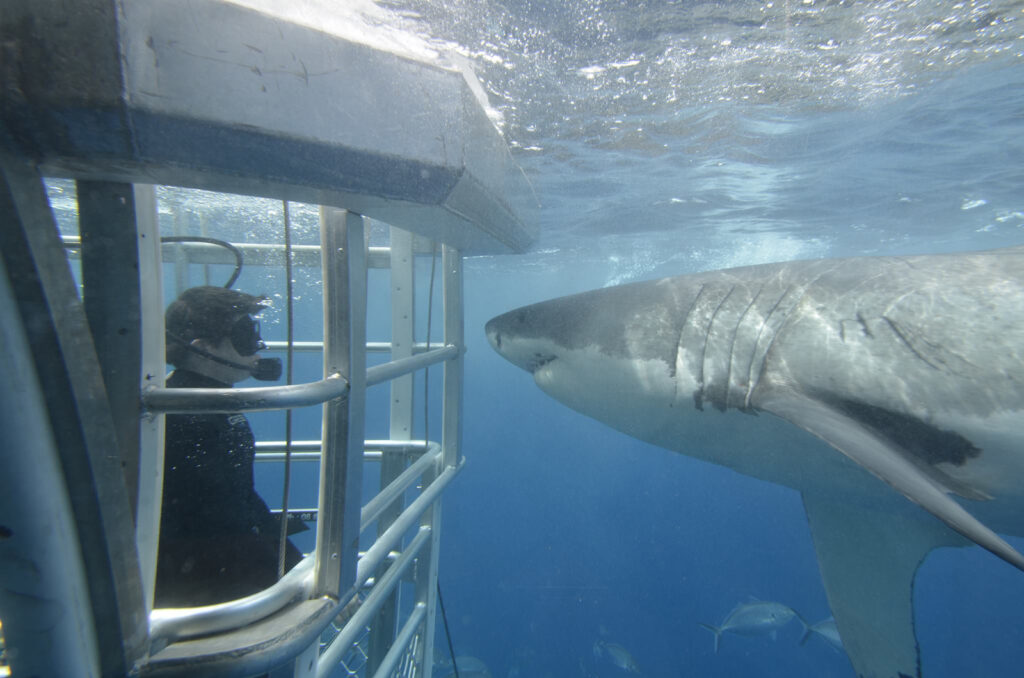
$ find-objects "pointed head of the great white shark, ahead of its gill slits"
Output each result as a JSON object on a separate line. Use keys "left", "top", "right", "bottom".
{"left": 485, "top": 281, "right": 693, "bottom": 439}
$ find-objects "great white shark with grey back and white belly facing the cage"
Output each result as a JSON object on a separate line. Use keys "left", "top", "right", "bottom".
{"left": 485, "top": 247, "right": 1024, "bottom": 678}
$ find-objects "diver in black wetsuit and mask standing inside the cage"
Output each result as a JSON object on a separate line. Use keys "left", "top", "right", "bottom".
{"left": 155, "top": 287, "right": 306, "bottom": 607}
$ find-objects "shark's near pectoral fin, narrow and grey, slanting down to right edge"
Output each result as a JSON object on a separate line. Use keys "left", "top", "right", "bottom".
{"left": 757, "top": 391, "right": 1024, "bottom": 570}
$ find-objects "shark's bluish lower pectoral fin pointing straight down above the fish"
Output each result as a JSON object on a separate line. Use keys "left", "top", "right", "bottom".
{"left": 803, "top": 493, "right": 963, "bottom": 678}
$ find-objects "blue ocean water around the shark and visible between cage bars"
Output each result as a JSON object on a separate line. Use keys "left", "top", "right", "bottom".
{"left": 39, "top": 0, "right": 1024, "bottom": 678}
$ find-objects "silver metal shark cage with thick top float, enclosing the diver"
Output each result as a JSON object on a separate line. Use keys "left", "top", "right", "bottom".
{"left": 0, "top": 0, "right": 534, "bottom": 678}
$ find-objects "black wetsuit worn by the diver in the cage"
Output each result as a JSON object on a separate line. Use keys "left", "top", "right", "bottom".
{"left": 156, "top": 370, "right": 302, "bottom": 607}
